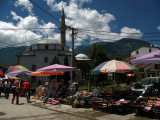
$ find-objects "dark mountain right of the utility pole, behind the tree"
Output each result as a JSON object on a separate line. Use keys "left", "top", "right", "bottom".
{"left": 75, "top": 38, "right": 150, "bottom": 57}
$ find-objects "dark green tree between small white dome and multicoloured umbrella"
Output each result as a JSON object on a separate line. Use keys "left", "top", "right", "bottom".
{"left": 89, "top": 44, "right": 109, "bottom": 68}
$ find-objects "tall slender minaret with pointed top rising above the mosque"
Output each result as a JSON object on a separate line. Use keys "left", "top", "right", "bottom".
{"left": 59, "top": 8, "right": 66, "bottom": 46}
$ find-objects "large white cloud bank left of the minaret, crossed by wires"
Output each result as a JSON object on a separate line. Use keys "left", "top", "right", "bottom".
{"left": 0, "top": 11, "right": 60, "bottom": 46}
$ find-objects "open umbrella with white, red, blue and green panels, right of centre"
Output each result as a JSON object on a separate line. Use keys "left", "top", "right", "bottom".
{"left": 92, "top": 60, "right": 138, "bottom": 74}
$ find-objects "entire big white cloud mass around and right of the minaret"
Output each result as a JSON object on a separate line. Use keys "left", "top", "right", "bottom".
{"left": 46, "top": 0, "right": 143, "bottom": 46}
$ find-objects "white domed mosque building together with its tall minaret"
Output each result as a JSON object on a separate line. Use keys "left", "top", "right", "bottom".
{"left": 18, "top": 9, "right": 71, "bottom": 79}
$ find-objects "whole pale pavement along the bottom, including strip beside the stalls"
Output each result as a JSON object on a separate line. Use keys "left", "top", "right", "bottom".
{"left": 0, "top": 95, "right": 158, "bottom": 120}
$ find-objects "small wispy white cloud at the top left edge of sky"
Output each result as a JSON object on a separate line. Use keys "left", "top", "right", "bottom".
{"left": 15, "top": 0, "right": 33, "bottom": 14}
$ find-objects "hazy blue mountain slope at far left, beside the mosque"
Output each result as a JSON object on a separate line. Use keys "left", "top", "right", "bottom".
{"left": 0, "top": 46, "right": 24, "bottom": 65}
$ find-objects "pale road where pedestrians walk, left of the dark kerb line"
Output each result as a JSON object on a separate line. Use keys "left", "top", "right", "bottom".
{"left": 0, "top": 96, "right": 90, "bottom": 120}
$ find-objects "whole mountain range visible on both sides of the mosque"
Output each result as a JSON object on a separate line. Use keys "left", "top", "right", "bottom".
{"left": 0, "top": 38, "right": 150, "bottom": 65}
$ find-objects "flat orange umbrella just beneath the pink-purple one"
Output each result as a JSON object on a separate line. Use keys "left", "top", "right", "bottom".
{"left": 30, "top": 71, "right": 64, "bottom": 76}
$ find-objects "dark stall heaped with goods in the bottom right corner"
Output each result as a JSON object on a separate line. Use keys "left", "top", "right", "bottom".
{"left": 134, "top": 84, "right": 160, "bottom": 118}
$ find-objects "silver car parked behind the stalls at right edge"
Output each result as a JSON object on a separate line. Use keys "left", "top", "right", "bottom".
{"left": 132, "top": 76, "right": 160, "bottom": 94}
